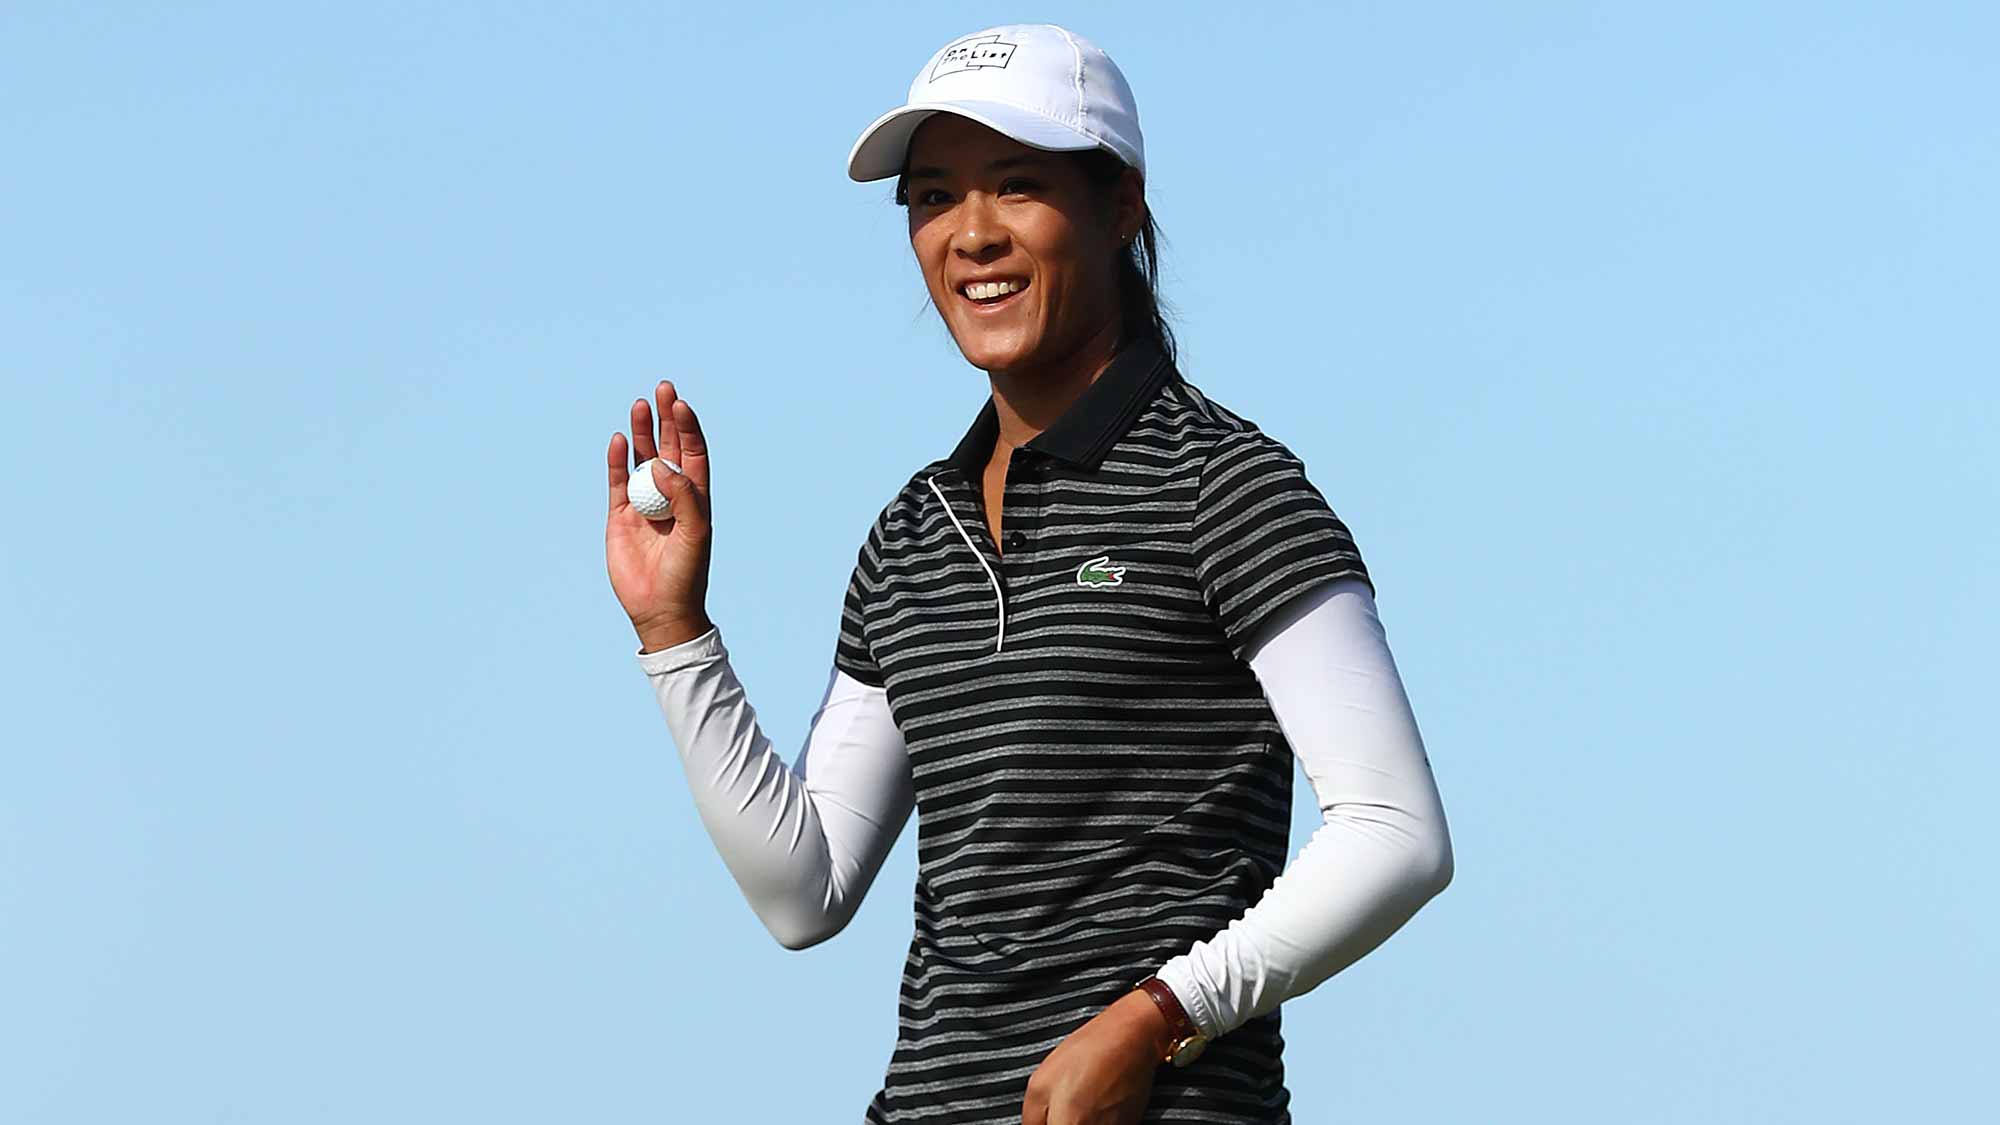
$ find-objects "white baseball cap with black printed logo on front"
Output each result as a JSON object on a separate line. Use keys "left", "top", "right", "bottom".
{"left": 848, "top": 24, "right": 1146, "bottom": 182}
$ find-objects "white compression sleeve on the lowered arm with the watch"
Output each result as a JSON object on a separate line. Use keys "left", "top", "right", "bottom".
{"left": 1158, "top": 579, "right": 1452, "bottom": 1039}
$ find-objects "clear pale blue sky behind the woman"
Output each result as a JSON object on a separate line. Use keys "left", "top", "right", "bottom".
{"left": 0, "top": 0, "right": 2000, "bottom": 1125}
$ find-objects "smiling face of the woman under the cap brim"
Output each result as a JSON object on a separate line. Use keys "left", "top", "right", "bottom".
{"left": 906, "top": 112, "right": 1144, "bottom": 372}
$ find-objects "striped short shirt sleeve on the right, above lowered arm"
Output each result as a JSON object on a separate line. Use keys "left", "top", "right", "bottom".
{"left": 1192, "top": 428, "right": 1374, "bottom": 655}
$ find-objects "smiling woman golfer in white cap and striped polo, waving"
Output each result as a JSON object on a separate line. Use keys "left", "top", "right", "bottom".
{"left": 606, "top": 24, "right": 1452, "bottom": 1125}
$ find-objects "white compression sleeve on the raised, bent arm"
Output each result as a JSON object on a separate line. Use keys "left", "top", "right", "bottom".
{"left": 636, "top": 629, "right": 916, "bottom": 949}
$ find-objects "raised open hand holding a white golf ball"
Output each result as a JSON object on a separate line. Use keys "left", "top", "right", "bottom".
{"left": 604, "top": 378, "right": 710, "bottom": 653}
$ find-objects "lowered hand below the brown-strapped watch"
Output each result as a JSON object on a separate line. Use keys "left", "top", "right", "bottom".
{"left": 1020, "top": 989, "right": 1168, "bottom": 1125}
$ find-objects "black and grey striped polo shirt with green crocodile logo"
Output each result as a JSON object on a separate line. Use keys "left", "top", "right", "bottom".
{"left": 834, "top": 340, "right": 1374, "bottom": 1125}
